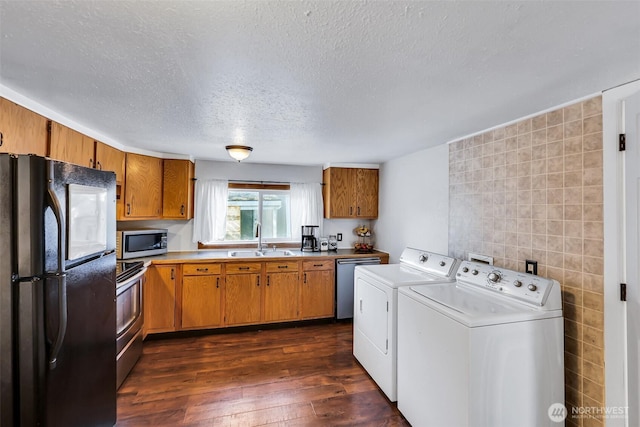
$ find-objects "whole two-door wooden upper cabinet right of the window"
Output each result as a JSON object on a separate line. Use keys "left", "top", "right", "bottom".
{"left": 322, "top": 168, "right": 378, "bottom": 219}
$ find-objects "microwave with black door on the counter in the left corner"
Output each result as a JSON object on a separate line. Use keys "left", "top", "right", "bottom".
{"left": 116, "top": 228, "right": 167, "bottom": 259}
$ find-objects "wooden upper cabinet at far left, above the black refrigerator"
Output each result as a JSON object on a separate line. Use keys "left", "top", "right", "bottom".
{"left": 0, "top": 98, "right": 48, "bottom": 156}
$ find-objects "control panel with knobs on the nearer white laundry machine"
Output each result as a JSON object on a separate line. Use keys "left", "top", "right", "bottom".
{"left": 456, "top": 261, "right": 560, "bottom": 310}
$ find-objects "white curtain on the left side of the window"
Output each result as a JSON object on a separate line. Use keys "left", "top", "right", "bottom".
{"left": 193, "top": 179, "right": 229, "bottom": 242}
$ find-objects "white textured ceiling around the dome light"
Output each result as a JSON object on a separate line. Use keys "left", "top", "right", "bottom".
{"left": 0, "top": 0, "right": 640, "bottom": 164}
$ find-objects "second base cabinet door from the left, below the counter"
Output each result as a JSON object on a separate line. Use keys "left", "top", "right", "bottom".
{"left": 182, "top": 275, "right": 223, "bottom": 328}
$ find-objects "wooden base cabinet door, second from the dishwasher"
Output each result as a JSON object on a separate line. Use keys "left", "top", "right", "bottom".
{"left": 264, "top": 271, "right": 299, "bottom": 322}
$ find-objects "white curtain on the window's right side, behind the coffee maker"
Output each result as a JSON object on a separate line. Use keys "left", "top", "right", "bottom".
{"left": 289, "top": 183, "right": 324, "bottom": 240}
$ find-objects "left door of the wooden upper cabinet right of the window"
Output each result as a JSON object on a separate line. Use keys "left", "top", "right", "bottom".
{"left": 323, "top": 168, "right": 356, "bottom": 218}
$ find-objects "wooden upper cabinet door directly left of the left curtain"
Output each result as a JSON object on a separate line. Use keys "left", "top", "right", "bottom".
{"left": 162, "top": 159, "right": 194, "bottom": 219}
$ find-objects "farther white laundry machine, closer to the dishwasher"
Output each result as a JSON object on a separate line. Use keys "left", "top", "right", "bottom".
{"left": 353, "top": 248, "right": 459, "bottom": 402}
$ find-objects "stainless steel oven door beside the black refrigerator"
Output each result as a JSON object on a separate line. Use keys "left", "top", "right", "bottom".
{"left": 116, "top": 269, "right": 146, "bottom": 358}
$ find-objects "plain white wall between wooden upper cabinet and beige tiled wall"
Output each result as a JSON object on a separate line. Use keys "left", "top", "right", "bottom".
{"left": 374, "top": 144, "right": 449, "bottom": 262}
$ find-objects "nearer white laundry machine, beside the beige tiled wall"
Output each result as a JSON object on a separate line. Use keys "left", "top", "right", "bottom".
{"left": 398, "top": 261, "right": 564, "bottom": 427}
